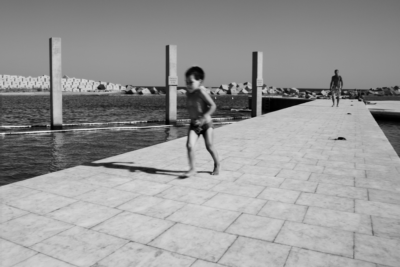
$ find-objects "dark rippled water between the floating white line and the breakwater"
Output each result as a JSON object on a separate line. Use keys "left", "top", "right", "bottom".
{"left": 0, "top": 95, "right": 249, "bottom": 125}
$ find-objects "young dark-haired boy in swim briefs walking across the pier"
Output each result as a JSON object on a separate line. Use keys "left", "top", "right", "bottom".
{"left": 185, "top": 67, "right": 220, "bottom": 177}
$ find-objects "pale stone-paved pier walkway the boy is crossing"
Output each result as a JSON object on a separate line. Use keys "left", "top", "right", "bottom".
{"left": 0, "top": 100, "right": 400, "bottom": 267}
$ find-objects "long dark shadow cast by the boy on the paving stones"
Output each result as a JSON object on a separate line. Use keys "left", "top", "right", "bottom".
{"left": 83, "top": 162, "right": 211, "bottom": 179}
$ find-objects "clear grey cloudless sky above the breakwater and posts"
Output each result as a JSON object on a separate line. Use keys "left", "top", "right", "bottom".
{"left": 0, "top": 0, "right": 400, "bottom": 88}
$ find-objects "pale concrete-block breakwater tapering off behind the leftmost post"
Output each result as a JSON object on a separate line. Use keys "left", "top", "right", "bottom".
{"left": 0, "top": 75, "right": 126, "bottom": 92}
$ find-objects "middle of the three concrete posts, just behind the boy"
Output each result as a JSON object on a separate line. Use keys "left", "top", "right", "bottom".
{"left": 165, "top": 45, "right": 178, "bottom": 124}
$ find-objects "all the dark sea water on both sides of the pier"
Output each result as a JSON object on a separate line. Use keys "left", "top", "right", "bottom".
{"left": 0, "top": 95, "right": 400, "bottom": 185}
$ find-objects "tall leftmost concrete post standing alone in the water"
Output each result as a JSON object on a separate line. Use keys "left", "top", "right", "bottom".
{"left": 49, "top": 37, "right": 63, "bottom": 130}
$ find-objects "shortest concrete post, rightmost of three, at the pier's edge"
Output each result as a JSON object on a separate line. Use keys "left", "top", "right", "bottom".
{"left": 251, "top": 52, "right": 264, "bottom": 117}
